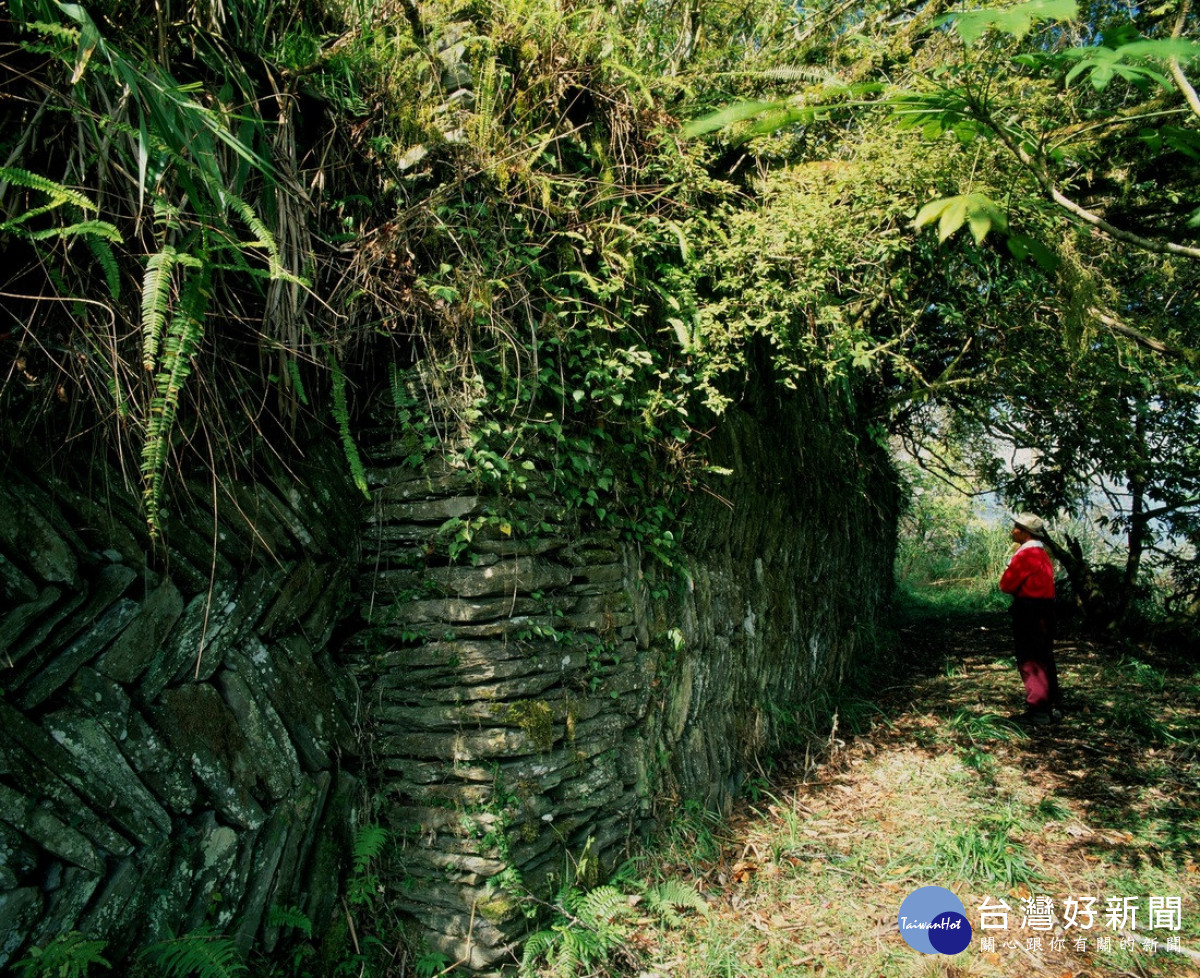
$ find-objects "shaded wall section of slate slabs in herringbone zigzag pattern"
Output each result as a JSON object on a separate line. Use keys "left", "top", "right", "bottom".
{"left": 0, "top": 446, "right": 362, "bottom": 971}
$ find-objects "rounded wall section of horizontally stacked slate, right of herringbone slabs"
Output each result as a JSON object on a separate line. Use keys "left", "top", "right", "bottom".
{"left": 346, "top": 374, "right": 895, "bottom": 971}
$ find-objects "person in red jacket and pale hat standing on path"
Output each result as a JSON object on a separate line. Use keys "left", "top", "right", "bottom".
{"left": 1000, "top": 512, "right": 1061, "bottom": 725}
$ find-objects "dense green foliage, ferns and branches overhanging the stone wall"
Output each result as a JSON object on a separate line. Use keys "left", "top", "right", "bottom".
{"left": 0, "top": 0, "right": 1200, "bottom": 607}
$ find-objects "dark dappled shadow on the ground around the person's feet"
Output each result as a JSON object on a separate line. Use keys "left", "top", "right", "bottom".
{"left": 875, "top": 611, "right": 1200, "bottom": 860}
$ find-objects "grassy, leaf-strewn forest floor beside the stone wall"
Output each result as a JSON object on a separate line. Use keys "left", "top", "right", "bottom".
{"left": 624, "top": 600, "right": 1200, "bottom": 978}
